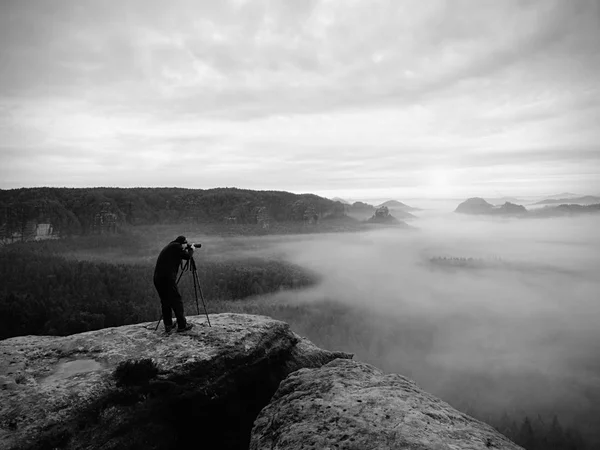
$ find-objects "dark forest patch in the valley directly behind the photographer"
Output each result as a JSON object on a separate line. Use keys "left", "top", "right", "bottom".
{"left": 0, "top": 244, "right": 316, "bottom": 339}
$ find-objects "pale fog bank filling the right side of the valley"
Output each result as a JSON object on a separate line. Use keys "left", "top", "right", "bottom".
{"left": 192, "top": 210, "right": 600, "bottom": 426}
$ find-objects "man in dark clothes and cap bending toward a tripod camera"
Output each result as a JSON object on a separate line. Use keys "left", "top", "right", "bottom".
{"left": 154, "top": 236, "right": 194, "bottom": 333}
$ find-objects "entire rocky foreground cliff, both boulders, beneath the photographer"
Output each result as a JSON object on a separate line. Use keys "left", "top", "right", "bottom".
{"left": 0, "top": 314, "right": 519, "bottom": 450}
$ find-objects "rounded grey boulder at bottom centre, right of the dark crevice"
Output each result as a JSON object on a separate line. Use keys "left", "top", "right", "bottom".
{"left": 250, "top": 359, "right": 521, "bottom": 450}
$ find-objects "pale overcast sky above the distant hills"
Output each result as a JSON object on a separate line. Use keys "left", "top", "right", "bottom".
{"left": 0, "top": 0, "right": 600, "bottom": 200}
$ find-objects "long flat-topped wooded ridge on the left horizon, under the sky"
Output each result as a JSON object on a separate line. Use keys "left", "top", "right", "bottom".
{"left": 0, "top": 187, "right": 344, "bottom": 238}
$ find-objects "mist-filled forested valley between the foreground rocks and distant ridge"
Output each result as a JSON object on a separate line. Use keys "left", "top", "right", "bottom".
{"left": 2, "top": 209, "right": 600, "bottom": 448}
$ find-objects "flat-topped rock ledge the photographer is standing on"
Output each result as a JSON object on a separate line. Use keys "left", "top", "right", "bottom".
{"left": 0, "top": 314, "right": 351, "bottom": 450}
